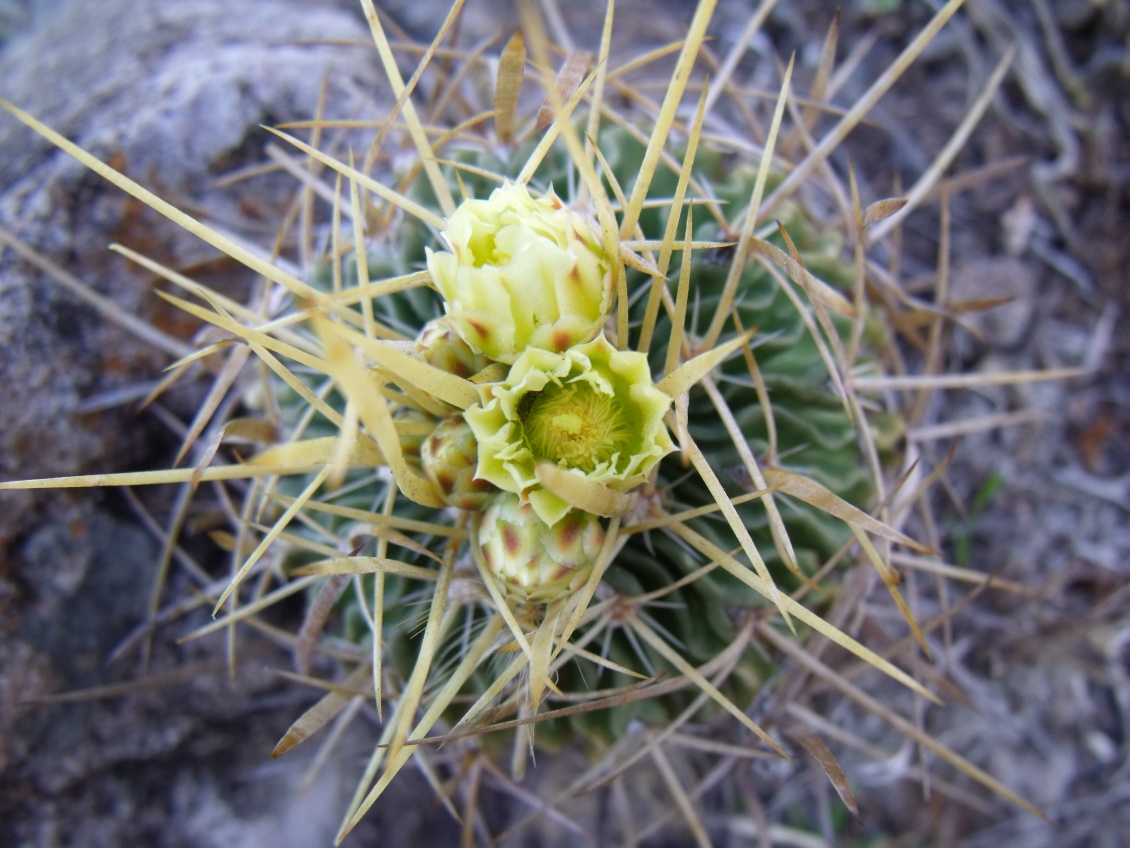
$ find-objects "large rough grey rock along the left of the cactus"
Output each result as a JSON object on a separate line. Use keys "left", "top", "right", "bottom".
{"left": 0, "top": 0, "right": 411, "bottom": 847}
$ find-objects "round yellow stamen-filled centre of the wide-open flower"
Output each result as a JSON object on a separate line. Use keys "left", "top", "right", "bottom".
{"left": 520, "top": 383, "right": 631, "bottom": 473}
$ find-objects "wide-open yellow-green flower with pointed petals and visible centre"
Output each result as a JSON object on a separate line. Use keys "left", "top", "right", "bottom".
{"left": 463, "top": 336, "right": 675, "bottom": 526}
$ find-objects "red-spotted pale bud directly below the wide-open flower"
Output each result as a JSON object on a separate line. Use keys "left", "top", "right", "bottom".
{"left": 477, "top": 492, "right": 605, "bottom": 604}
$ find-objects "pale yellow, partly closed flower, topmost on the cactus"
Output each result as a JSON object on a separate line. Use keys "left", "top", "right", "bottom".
{"left": 426, "top": 183, "right": 612, "bottom": 364}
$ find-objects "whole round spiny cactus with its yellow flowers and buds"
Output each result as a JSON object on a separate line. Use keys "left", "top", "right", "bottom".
{"left": 0, "top": 2, "right": 1048, "bottom": 834}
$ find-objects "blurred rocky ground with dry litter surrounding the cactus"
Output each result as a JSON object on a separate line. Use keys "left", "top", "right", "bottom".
{"left": 0, "top": 0, "right": 1130, "bottom": 848}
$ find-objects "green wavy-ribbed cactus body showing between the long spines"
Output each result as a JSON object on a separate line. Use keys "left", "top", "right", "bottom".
{"left": 264, "top": 113, "right": 898, "bottom": 768}
